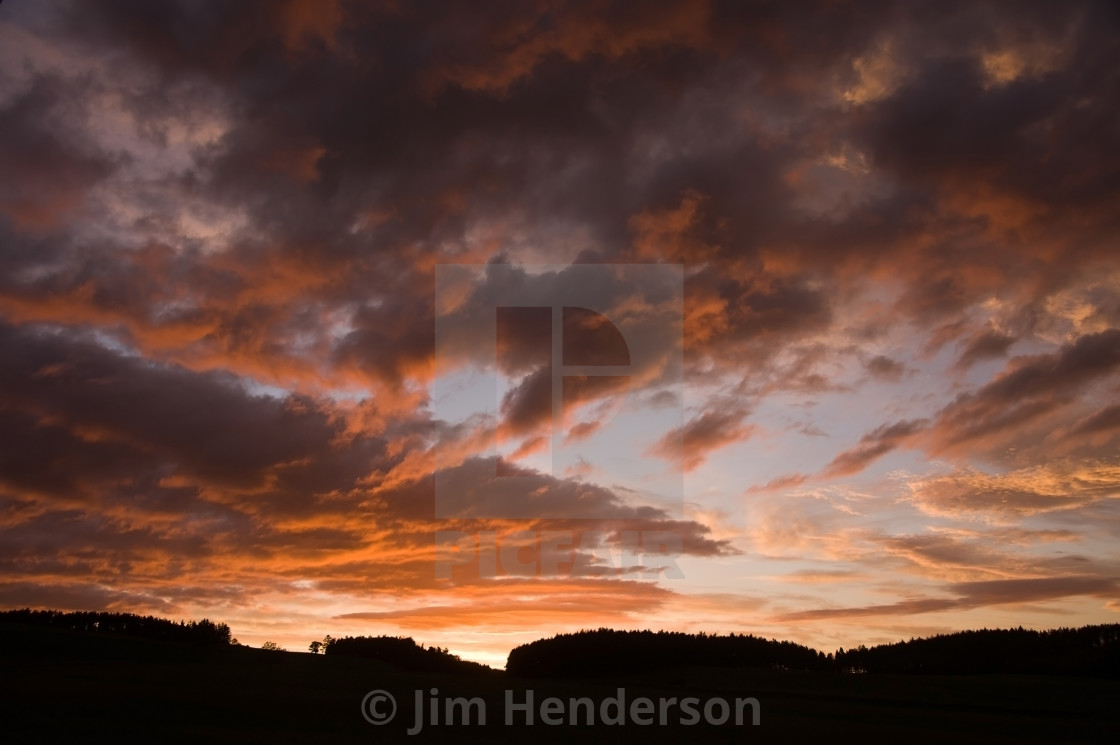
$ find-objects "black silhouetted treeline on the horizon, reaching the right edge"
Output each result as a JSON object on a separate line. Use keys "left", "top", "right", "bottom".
{"left": 836, "top": 624, "right": 1120, "bottom": 677}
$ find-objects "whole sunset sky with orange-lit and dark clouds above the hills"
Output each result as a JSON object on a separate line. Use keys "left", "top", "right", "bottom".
{"left": 0, "top": 0, "right": 1120, "bottom": 667}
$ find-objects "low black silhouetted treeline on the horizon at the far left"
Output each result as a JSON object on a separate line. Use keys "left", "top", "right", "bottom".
{"left": 0, "top": 608, "right": 230, "bottom": 644}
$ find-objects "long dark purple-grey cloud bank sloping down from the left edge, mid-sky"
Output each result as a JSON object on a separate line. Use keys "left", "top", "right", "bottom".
{"left": 0, "top": 326, "right": 349, "bottom": 485}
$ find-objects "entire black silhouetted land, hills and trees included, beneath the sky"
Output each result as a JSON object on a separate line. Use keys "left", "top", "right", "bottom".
{"left": 0, "top": 611, "right": 1120, "bottom": 745}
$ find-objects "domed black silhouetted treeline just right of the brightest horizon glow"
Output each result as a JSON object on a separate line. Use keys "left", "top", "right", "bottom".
{"left": 505, "top": 628, "right": 833, "bottom": 677}
